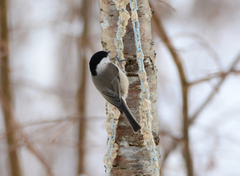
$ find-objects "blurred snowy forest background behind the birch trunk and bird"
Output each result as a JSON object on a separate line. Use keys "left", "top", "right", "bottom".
{"left": 0, "top": 0, "right": 240, "bottom": 176}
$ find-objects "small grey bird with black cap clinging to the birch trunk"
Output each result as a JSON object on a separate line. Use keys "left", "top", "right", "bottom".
{"left": 89, "top": 51, "right": 141, "bottom": 132}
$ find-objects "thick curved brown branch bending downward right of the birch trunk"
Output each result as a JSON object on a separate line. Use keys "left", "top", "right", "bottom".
{"left": 152, "top": 12, "right": 193, "bottom": 176}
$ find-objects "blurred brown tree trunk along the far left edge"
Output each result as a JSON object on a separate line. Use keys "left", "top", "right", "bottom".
{"left": 0, "top": 0, "right": 21, "bottom": 176}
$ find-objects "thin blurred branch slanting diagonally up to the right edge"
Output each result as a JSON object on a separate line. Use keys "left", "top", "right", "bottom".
{"left": 188, "top": 54, "right": 240, "bottom": 126}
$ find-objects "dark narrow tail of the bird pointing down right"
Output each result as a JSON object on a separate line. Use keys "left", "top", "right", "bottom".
{"left": 121, "top": 100, "right": 141, "bottom": 133}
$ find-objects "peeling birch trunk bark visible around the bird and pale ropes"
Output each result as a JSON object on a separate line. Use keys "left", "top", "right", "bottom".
{"left": 99, "top": 0, "right": 159, "bottom": 176}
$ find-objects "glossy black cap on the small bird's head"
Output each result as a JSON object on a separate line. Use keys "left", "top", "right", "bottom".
{"left": 89, "top": 51, "right": 110, "bottom": 76}
